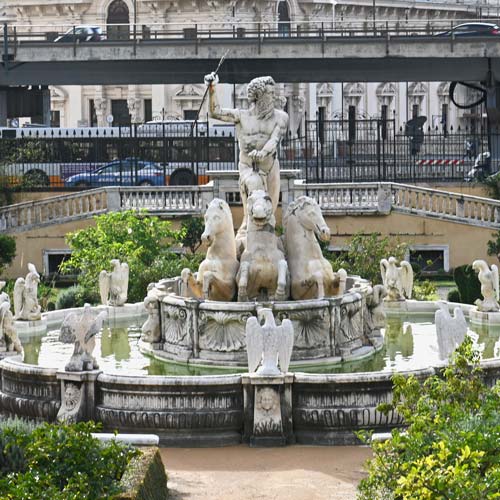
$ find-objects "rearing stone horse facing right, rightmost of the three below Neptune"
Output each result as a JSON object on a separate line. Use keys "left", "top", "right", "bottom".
{"left": 283, "top": 196, "right": 347, "bottom": 300}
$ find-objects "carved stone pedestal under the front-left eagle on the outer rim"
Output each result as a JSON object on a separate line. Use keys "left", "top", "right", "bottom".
{"left": 57, "top": 370, "right": 101, "bottom": 423}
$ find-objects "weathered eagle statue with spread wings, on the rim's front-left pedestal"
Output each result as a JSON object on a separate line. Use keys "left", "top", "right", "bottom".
{"left": 59, "top": 304, "right": 108, "bottom": 372}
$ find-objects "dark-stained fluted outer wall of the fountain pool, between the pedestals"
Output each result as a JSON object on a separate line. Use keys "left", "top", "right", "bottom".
{"left": 0, "top": 359, "right": 500, "bottom": 446}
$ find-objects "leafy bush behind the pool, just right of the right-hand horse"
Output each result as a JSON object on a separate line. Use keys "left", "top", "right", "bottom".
{"left": 323, "top": 232, "right": 408, "bottom": 284}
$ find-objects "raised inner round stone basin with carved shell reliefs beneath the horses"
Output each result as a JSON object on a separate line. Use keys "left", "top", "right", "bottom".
{"left": 148, "top": 276, "right": 383, "bottom": 368}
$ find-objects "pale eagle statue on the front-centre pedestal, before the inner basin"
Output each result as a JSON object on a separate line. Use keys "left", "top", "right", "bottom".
{"left": 246, "top": 309, "right": 293, "bottom": 376}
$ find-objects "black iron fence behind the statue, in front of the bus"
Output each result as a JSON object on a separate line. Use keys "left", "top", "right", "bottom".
{"left": 0, "top": 119, "right": 492, "bottom": 190}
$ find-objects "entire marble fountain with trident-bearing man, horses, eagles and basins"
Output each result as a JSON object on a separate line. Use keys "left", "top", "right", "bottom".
{"left": 0, "top": 74, "right": 500, "bottom": 446}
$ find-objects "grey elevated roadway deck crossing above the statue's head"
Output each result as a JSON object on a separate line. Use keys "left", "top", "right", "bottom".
{"left": 0, "top": 33, "right": 500, "bottom": 86}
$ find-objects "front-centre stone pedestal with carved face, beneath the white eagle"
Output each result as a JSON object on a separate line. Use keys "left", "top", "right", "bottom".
{"left": 241, "top": 373, "right": 294, "bottom": 447}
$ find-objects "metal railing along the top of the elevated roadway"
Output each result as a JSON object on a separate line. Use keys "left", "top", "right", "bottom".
{"left": 4, "top": 17, "right": 499, "bottom": 48}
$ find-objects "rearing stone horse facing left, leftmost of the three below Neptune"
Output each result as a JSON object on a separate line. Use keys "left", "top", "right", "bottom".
{"left": 181, "top": 198, "right": 239, "bottom": 301}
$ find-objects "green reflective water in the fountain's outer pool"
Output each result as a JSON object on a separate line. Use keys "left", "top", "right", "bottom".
{"left": 20, "top": 315, "right": 500, "bottom": 375}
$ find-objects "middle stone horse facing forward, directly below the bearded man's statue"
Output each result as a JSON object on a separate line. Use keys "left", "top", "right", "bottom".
{"left": 236, "top": 189, "right": 289, "bottom": 302}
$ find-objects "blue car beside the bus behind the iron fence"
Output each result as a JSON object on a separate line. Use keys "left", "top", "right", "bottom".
{"left": 64, "top": 158, "right": 165, "bottom": 187}
